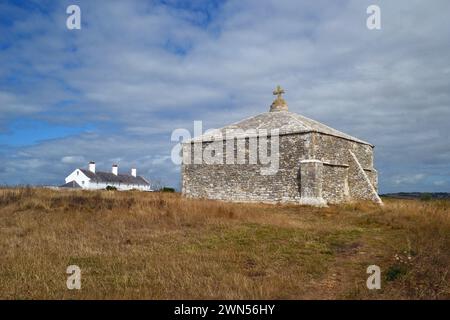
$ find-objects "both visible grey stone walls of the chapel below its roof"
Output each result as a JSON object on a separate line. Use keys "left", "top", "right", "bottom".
{"left": 181, "top": 133, "right": 377, "bottom": 203}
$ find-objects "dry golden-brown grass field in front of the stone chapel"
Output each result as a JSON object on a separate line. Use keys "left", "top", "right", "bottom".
{"left": 0, "top": 188, "right": 450, "bottom": 299}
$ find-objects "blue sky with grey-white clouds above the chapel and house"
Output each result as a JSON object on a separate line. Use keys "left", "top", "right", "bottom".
{"left": 0, "top": 0, "right": 450, "bottom": 193}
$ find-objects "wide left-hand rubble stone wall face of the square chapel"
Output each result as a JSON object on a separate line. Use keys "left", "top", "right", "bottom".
{"left": 182, "top": 134, "right": 310, "bottom": 202}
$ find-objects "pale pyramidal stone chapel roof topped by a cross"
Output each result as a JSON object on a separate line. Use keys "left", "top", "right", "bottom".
{"left": 186, "top": 86, "right": 373, "bottom": 146}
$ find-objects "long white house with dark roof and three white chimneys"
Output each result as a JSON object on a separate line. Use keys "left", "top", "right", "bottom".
{"left": 60, "top": 161, "right": 152, "bottom": 191}
